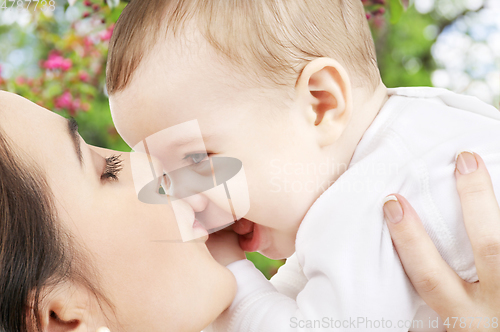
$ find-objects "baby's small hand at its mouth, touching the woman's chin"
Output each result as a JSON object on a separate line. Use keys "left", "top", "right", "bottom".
{"left": 206, "top": 228, "right": 246, "bottom": 266}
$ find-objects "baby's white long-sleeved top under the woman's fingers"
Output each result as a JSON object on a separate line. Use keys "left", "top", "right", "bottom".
{"left": 205, "top": 88, "right": 500, "bottom": 332}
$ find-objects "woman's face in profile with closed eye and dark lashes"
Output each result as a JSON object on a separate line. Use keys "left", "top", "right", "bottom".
{"left": 0, "top": 92, "right": 236, "bottom": 331}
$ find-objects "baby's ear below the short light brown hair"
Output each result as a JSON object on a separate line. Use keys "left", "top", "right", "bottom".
{"left": 296, "top": 58, "right": 353, "bottom": 145}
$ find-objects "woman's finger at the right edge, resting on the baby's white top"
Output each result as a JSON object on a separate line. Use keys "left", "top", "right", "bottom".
{"left": 455, "top": 152, "right": 500, "bottom": 291}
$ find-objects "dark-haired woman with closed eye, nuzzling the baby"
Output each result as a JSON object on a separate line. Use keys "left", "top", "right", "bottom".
{"left": 0, "top": 92, "right": 236, "bottom": 332}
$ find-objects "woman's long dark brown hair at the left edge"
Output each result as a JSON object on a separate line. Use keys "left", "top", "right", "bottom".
{"left": 0, "top": 128, "right": 110, "bottom": 332}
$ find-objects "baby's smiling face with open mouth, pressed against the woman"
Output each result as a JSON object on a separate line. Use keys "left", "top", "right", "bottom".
{"left": 110, "top": 32, "right": 328, "bottom": 258}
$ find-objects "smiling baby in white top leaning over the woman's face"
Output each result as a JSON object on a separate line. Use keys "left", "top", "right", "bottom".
{"left": 107, "top": 0, "right": 500, "bottom": 332}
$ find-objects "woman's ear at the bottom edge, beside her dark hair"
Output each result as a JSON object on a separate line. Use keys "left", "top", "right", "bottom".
{"left": 38, "top": 284, "right": 95, "bottom": 332}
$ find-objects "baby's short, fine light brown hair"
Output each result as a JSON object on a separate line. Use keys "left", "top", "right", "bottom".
{"left": 106, "top": 0, "right": 380, "bottom": 95}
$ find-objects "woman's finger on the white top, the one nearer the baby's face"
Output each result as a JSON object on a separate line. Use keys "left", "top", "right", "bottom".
{"left": 384, "top": 194, "right": 467, "bottom": 314}
